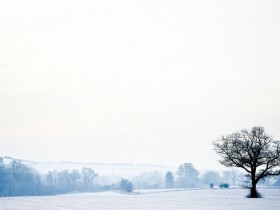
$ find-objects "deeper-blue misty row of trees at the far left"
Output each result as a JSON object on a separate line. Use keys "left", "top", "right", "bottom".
{"left": 0, "top": 157, "right": 97, "bottom": 196}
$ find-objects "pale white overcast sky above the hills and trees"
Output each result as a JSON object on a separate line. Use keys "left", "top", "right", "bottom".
{"left": 0, "top": 0, "right": 280, "bottom": 169}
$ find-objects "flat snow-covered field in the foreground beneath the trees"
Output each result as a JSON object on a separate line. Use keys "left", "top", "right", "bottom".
{"left": 0, "top": 189, "right": 280, "bottom": 210}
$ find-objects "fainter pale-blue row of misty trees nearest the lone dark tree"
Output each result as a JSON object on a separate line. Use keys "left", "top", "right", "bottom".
{"left": 130, "top": 163, "right": 244, "bottom": 189}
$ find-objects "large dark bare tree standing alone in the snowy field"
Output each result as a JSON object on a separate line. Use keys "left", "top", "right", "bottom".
{"left": 213, "top": 127, "right": 280, "bottom": 198}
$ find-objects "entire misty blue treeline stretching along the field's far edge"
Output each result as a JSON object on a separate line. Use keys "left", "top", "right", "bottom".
{"left": 0, "top": 157, "right": 280, "bottom": 197}
